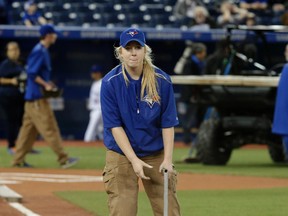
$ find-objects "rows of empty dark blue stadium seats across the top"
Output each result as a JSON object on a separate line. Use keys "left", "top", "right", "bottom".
{"left": 7, "top": 0, "right": 281, "bottom": 29}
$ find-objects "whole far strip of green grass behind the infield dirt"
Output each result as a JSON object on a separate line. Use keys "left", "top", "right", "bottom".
{"left": 0, "top": 144, "right": 288, "bottom": 178}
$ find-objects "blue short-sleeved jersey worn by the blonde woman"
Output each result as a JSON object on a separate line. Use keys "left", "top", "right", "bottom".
{"left": 100, "top": 65, "right": 178, "bottom": 157}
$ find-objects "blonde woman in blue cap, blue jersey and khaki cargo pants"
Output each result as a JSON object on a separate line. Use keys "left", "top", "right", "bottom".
{"left": 101, "top": 28, "right": 180, "bottom": 216}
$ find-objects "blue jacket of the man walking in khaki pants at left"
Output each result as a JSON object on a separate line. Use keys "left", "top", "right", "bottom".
{"left": 25, "top": 43, "right": 51, "bottom": 100}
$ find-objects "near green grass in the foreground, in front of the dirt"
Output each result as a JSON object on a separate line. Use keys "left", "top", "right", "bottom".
{"left": 57, "top": 188, "right": 288, "bottom": 216}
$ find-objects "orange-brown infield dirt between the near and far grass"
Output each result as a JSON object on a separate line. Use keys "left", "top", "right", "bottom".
{"left": 0, "top": 168, "right": 288, "bottom": 216}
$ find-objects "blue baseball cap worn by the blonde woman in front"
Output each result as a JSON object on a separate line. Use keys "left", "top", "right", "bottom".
{"left": 120, "top": 28, "right": 146, "bottom": 47}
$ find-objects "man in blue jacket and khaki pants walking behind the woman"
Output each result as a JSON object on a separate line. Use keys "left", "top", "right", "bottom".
{"left": 13, "top": 24, "right": 78, "bottom": 168}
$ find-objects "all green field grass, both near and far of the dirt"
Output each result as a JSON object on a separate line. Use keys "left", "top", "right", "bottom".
{"left": 0, "top": 144, "right": 288, "bottom": 216}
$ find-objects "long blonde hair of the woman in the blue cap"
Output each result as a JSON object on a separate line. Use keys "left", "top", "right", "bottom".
{"left": 114, "top": 44, "right": 160, "bottom": 103}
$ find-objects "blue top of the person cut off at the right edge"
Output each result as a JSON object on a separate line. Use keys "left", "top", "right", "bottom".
{"left": 272, "top": 64, "right": 288, "bottom": 136}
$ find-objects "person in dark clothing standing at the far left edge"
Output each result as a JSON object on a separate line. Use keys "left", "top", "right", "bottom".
{"left": 0, "top": 42, "right": 24, "bottom": 154}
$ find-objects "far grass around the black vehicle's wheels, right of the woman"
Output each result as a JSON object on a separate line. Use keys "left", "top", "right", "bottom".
{"left": 174, "top": 149, "right": 288, "bottom": 178}
